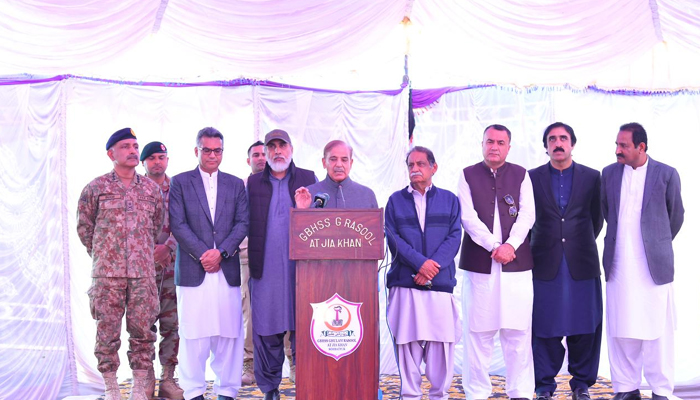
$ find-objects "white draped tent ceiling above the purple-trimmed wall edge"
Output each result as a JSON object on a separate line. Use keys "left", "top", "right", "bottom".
{"left": 0, "top": 0, "right": 700, "bottom": 90}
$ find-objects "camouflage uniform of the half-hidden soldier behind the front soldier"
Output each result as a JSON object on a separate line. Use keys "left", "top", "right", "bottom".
{"left": 151, "top": 176, "right": 180, "bottom": 365}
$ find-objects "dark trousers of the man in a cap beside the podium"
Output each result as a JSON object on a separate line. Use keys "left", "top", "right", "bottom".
{"left": 253, "top": 328, "right": 296, "bottom": 393}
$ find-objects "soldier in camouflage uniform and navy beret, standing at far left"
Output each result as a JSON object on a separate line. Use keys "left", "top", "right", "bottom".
{"left": 78, "top": 128, "right": 164, "bottom": 400}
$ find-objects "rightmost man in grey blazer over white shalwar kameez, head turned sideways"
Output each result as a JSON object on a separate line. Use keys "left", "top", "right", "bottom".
{"left": 601, "top": 122, "right": 684, "bottom": 400}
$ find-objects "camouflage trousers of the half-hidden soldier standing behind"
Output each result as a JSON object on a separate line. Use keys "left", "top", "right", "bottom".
{"left": 151, "top": 264, "right": 180, "bottom": 365}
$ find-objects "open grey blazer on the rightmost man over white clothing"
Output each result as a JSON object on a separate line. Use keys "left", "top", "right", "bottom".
{"left": 601, "top": 156, "right": 684, "bottom": 285}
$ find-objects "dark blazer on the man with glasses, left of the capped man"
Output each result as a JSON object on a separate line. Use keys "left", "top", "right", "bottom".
{"left": 170, "top": 167, "right": 248, "bottom": 286}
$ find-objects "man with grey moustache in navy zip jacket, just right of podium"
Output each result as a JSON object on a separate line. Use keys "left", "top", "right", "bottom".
{"left": 385, "top": 146, "right": 462, "bottom": 400}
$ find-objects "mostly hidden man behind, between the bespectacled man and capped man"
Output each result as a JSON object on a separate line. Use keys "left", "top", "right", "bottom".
{"left": 240, "top": 140, "right": 264, "bottom": 386}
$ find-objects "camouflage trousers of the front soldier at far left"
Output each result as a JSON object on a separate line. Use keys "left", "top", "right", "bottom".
{"left": 88, "top": 277, "right": 158, "bottom": 373}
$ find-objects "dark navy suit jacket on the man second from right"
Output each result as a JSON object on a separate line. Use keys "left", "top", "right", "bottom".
{"left": 529, "top": 163, "right": 603, "bottom": 281}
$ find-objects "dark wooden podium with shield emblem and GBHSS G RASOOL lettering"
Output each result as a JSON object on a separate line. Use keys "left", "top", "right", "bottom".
{"left": 289, "top": 209, "right": 384, "bottom": 400}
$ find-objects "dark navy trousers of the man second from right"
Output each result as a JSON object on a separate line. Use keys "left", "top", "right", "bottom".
{"left": 532, "top": 322, "right": 603, "bottom": 395}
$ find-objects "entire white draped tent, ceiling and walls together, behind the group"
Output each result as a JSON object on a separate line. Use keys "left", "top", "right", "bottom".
{"left": 0, "top": 0, "right": 700, "bottom": 399}
